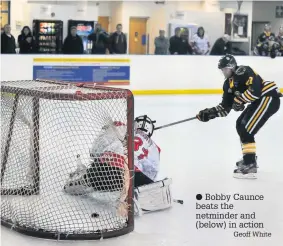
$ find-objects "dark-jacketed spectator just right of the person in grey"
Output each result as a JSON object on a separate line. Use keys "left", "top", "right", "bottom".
{"left": 169, "top": 27, "right": 193, "bottom": 55}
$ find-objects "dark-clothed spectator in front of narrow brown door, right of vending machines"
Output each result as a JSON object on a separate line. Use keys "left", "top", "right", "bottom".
{"left": 88, "top": 23, "right": 109, "bottom": 54}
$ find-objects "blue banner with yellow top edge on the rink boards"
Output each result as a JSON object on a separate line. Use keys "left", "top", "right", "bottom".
{"left": 33, "top": 58, "right": 130, "bottom": 85}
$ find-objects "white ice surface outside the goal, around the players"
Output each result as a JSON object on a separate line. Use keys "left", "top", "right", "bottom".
{"left": 1, "top": 95, "right": 283, "bottom": 246}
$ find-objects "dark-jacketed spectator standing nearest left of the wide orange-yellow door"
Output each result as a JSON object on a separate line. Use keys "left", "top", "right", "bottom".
{"left": 109, "top": 24, "right": 127, "bottom": 54}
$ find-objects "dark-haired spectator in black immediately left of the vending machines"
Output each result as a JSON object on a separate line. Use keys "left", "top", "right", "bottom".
{"left": 18, "top": 26, "right": 35, "bottom": 54}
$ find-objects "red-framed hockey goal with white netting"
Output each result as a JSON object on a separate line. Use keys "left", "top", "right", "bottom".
{"left": 1, "top": 80, "right": 134, "bottom": 239}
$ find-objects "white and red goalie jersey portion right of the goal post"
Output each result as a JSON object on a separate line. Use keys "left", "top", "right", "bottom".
{"left": 134, "top": 129, "right": 160, "bottom": 181}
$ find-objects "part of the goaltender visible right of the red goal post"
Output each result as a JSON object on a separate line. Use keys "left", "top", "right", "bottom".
{"left": 134, "top": 115, "right": 172, "bottom": 214}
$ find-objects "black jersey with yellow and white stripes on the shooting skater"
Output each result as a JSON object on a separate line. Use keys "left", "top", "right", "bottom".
{"left": 221, "top": 66, "right": 280, "bottom": 112}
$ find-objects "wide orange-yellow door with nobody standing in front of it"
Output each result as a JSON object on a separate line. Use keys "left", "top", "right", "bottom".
{"left": 129, "top": 17, "right": 148, "bottom": 55}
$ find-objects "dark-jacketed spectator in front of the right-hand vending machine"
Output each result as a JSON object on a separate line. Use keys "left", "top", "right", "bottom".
{"left": 63, "top": 26, "right": 84, "bottom": 54}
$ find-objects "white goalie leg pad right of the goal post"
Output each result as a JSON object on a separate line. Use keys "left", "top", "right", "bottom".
{"left": 135, "top": 178, "right": 173, "bottom": 213}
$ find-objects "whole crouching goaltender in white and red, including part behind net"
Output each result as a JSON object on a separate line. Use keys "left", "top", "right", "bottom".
{"left": 64, "top": 115, "right": 172, "bottom": 214}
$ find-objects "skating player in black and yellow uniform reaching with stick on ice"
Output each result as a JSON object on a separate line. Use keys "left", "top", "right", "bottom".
{"left": 197, "top": 55, "right": 282, "bottom": 178}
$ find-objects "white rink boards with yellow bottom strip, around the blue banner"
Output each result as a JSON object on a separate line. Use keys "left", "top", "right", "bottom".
{"left": 1, "top": 55, "right": 283, "bottom": 95}
